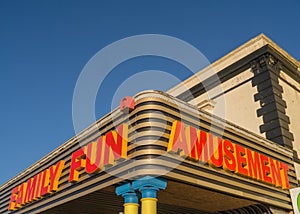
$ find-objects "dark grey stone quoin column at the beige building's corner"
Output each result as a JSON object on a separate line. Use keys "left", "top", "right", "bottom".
{"left": 250, "top": 53, "right": 294, "bottom": 148}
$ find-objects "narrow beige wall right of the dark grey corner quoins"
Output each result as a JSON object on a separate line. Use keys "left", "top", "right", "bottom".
{"left": 279, "top": 72, "right": 300, "bottom": 179}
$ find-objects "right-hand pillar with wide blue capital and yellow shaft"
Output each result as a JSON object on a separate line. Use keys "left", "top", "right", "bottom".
{"left": 132, "top": 176, "right": 167, "bottom": 214}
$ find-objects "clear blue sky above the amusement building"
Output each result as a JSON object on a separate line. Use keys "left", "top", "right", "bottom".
{"left": 0, "top": 0, "right": 300, "bottom": 184}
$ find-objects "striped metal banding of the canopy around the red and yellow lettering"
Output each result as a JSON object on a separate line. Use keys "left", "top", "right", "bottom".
{"left": 0, "top": 92, "right": 297, "bottom": 213}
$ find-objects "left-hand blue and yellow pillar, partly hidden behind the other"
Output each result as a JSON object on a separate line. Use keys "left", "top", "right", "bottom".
{"left": 116, "top": 183, "right": 139, "bottom": 214}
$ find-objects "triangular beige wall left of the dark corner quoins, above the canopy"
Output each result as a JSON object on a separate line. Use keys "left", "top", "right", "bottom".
{"left": 190, "top": 69, "right": 265, "bottom": 137}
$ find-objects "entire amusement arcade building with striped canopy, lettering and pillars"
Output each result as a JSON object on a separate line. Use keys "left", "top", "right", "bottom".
{"left": 0, "top": 35, "right": 300, "bottom": 214}
